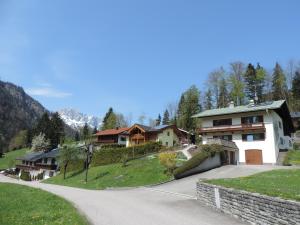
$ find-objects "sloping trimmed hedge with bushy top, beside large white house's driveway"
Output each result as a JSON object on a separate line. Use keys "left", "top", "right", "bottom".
{"left": 174, "top": 144, "right": 223, "bottom": 178}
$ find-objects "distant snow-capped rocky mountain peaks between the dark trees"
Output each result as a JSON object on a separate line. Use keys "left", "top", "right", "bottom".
{"left": 58, "top": 109, "right": 102, "bottom": 129}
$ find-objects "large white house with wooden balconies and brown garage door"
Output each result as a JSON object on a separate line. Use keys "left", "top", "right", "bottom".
{"left": 193, "top": 100, "right": 294, "bottom": 164}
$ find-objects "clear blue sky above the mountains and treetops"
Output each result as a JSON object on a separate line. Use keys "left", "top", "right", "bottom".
{"left": 0, "top": 0, "right": 300, "bottom": 121}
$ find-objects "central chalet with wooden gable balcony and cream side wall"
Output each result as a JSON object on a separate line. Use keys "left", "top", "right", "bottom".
{"left": 127, "top": 124, "right": 183, "bottom": 147}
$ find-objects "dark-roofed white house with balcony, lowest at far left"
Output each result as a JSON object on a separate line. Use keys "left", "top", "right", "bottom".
{"left": 16, "top": 149, "right": 59, "bottom": 179}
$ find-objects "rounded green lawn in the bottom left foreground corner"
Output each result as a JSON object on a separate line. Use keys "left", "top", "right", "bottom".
{"left": 0, "top": 183, "right": 89, "bottom": 225}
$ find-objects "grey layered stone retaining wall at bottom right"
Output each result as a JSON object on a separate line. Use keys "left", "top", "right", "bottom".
{"left": 197, "top": 181, "right": 300, "bottom": 225}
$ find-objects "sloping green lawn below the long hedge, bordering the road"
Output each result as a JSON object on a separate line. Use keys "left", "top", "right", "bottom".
{"left": 44, "top": 155, "right": 172, "bottom": 189}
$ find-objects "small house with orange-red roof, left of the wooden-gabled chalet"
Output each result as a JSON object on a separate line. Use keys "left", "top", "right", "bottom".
{"left": 94, "top": 127, "right": 129, "bottom": 146}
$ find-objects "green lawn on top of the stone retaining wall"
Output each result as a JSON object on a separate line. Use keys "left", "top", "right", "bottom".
{"left": 205, "top": 169, "right": 300, "bottom": 201}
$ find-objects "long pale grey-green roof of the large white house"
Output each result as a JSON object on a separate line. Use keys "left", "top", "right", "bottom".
{"left": 193, "top": 100, "right": 285, "bottom": 118}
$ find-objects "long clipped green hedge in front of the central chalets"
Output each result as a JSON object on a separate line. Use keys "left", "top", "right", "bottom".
{"left": 91, "top": 142, "right": 162, "bottom": 166}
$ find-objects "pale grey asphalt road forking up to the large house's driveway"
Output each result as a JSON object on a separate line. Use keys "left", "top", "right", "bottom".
{"left": 0, "top": 166, "right": 280, "bottom": 225}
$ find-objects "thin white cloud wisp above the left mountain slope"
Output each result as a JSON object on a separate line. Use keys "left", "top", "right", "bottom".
{"left": 25, "top": 87, "right": 72, "bottom": 98}
